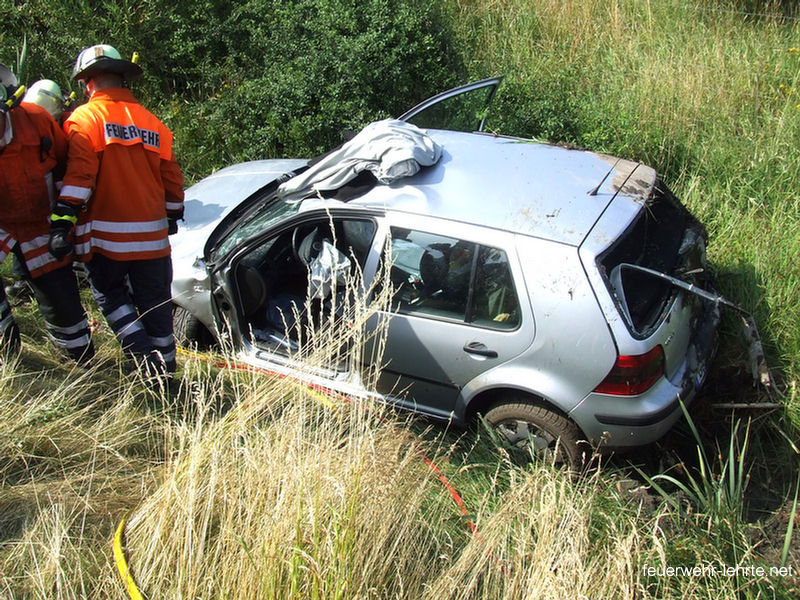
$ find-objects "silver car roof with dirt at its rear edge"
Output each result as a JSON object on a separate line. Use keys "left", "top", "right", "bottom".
{"left": 350, "top": 129, "right": 656, "bottom": 246}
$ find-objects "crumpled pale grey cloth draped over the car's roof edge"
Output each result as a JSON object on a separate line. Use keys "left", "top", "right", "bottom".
{"left": 278, "top": 119, "right": 442, "bottom": 202}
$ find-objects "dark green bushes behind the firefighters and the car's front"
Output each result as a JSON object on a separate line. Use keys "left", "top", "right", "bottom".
{"left": 0, "top": 0, "right": 464, "bottom": 181}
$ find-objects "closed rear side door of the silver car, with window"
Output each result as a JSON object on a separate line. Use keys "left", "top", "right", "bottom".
{"left": 365, "top": 216, "right": 534, "bottom": 419}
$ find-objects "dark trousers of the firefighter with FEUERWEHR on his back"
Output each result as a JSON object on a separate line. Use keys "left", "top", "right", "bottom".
{"left": 85, "top": 254, "right": 176, "bottom": 373}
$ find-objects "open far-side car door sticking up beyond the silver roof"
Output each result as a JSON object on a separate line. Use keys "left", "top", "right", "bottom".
{"left": 398, "top": 77, "right": 503, "bottom": 132}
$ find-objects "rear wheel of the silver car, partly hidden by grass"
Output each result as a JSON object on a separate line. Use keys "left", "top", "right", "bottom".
{"left": 483, "top": 400, "right": 591, "bottom": 472}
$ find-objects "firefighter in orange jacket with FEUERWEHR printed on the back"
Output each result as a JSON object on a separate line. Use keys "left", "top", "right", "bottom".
{"left": 49, "top": 45, "right": 183, "bottom": 373}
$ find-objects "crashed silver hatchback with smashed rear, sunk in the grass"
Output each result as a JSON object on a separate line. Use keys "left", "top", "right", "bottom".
{"left": 173, "top": 80, "right": 719, "bottom": 467}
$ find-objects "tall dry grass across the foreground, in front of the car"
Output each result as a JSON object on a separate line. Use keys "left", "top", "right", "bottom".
{"left": 0, "top": 264, "right": 800, "bottom": 600}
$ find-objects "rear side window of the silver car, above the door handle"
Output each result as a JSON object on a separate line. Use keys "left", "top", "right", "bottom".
{"left": 391, "top": 228, "right": 520, "bottom": 329}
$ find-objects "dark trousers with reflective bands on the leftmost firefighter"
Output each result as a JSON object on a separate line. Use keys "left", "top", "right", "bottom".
{"left": 0, "top": 245, "right": 94, "bottom": 363}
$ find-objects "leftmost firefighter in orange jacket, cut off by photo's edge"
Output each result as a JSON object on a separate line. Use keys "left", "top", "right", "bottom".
{"left": 0, "top": 64, "right": 94, "bottom": 364}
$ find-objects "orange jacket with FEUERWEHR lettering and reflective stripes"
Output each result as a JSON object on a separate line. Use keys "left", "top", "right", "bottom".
{"left": 60, "top": 88, "right": 183, "bottom": 261}
